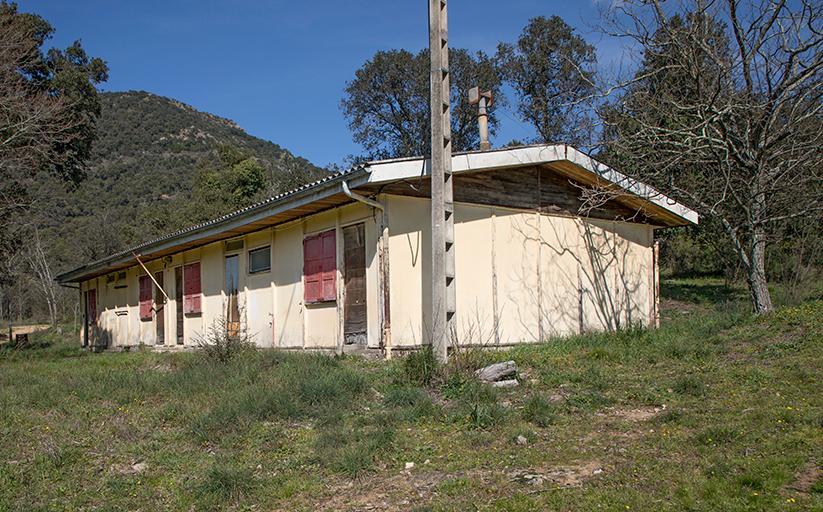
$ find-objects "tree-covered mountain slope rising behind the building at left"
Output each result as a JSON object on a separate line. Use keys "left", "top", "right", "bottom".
{"left": 34, "top": 92, "right": 325, "bottom": 271}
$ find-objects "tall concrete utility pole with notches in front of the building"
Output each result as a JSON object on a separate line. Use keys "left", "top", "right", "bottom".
{"left": 429, "top": 0, "right": 457, "bottom": 363}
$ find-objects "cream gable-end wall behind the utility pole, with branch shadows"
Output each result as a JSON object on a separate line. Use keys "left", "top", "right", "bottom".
{"left": 388, "top": 196, "right": 653, "bottom": 346}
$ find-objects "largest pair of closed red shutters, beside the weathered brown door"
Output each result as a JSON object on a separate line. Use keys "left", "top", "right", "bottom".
{"left": 303, "top": 230, "right": 337, "bottom": 303}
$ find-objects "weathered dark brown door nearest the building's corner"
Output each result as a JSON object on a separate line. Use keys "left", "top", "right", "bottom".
{"left": 343, "top": 223, "right": 367, "bottom": 345}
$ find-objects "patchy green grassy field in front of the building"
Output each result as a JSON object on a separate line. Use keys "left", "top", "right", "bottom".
{"left": 0, "top": 280, "right": 823, "bottom": 511}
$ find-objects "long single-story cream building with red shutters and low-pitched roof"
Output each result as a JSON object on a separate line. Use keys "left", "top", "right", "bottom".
{"left": 57, "top": 144, "right": 698, "bottom": 354}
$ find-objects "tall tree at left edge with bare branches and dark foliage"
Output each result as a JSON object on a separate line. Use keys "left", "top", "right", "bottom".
{"left": 0, "top": 2, "right": 108, "bottom": 321}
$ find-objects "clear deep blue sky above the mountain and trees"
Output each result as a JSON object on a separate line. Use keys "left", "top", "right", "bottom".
{"left": 19, "top": 0, "right": 620, "bottom": 166}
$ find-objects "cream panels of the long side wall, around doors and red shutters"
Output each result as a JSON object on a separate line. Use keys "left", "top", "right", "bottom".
{"left": 81, "top": 203, "right": 380, "bottom": 349}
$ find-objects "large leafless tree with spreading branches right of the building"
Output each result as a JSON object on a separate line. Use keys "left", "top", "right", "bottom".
{"left": 603, "top": 0, "right": 823, "bottom": 313}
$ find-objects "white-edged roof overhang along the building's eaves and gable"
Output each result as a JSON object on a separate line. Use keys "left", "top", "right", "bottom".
{"left": 56, "top": 144, "right": 698, "bottom": 284}
